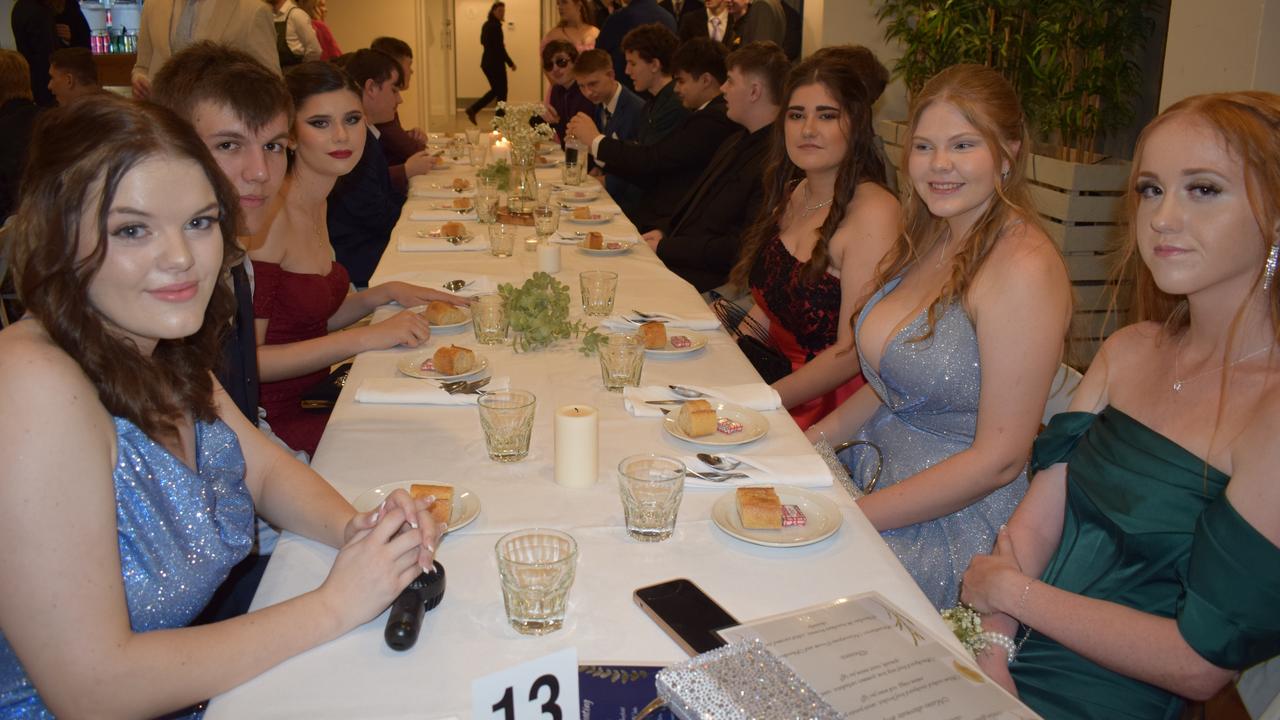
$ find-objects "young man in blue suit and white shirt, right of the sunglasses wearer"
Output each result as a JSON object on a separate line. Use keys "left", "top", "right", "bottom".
{"left": 567, "top": 49, "right": 644, "bottom": 209}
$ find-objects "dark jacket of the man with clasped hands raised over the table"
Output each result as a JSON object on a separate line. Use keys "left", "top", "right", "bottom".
{"left": 596, "top": 96, "right": 739, "bottom": 231}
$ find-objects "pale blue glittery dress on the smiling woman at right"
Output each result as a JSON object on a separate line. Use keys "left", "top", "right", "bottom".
{"left": 844, "top": 277, "right": 1029, "bottom": 610}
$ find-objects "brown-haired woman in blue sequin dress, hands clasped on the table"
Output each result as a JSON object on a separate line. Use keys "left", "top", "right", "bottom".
{"left": 0, "top": 96, "right": 439, "bottom": 717}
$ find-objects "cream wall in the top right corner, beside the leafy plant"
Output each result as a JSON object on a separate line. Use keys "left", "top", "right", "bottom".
{"left": 1160, "top": 0, "right": 1280, "bottom": 109}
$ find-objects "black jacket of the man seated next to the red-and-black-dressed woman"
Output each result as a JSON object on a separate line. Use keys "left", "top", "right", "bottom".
{"left": 658, "top": 124, "right": 773, "bottom": 292}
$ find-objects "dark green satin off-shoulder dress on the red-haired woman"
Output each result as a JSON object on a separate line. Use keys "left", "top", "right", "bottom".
{"left": 1010, "top": 406, "right": 1280, "bottom": 720}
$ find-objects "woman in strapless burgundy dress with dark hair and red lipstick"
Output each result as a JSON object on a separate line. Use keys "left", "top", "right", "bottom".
{"left": 248, "top": 61, "right": 465, "bottom": 455}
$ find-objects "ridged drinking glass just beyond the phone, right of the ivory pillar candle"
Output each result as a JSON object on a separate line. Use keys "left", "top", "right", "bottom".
{"left": 618, "top": 454, "right": 685, "bottom": 542}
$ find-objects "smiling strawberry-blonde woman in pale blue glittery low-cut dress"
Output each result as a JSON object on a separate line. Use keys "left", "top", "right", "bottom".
{"left": 808, "top": 65, "right": 1071, "bottom": 609}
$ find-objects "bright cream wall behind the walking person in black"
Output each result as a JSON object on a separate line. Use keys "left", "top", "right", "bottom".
{"left": 453, "top": 0, "right": 543, "bottom": 102}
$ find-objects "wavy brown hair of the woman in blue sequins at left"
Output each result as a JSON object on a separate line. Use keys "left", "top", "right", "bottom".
{"left": 10, "top": 95, "right": 241, "bottom": 441}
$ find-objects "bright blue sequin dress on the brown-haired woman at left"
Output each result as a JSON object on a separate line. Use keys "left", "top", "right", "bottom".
{"left": 0, "top": 418, "right": 253, "bottom": 719}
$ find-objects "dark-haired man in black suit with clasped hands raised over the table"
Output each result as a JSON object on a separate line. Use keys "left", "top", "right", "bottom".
{"left": 570, "top": 37, "right": 737, "bottom": 231}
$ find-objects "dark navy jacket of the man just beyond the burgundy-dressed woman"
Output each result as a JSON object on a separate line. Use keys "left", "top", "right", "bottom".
{"left": 329, "top": 131, "right": 404, "bottom": 287}
